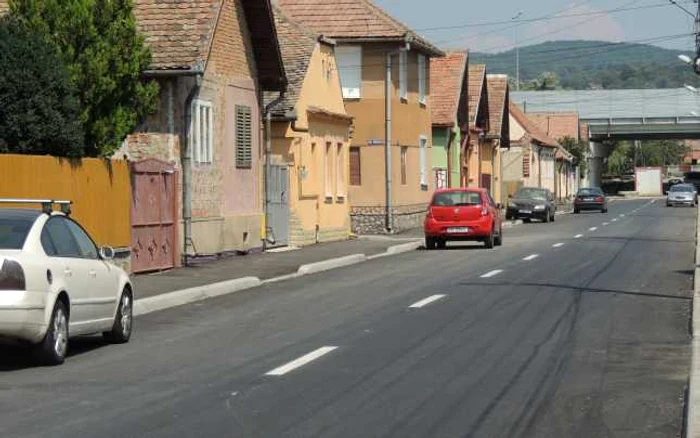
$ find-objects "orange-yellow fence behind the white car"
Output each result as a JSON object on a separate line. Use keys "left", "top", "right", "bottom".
{"left": 0, "top": 154, "right": 131, "bottom": 247}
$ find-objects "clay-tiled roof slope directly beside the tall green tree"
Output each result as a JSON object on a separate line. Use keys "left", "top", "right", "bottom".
{"left": 134, "top": 0, "right": 221, "bottom": 70}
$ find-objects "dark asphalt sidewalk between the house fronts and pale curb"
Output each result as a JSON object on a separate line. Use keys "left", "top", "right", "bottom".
{"left": 132, "top": 239, "right": 415, "bottom": 299}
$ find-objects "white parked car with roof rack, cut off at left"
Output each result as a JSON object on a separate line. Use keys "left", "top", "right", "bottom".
{"left": 0, "top": 199, "right": 134, "bottom": 365}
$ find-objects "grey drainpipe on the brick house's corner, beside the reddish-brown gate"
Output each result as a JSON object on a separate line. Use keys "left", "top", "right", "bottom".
{"left": 182, "top": 70, "right": 204, "bottom": 266}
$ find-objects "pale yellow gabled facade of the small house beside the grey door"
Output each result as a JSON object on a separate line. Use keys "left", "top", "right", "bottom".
{"left": 273, "top": 44, "right": 350, "bottom": 244}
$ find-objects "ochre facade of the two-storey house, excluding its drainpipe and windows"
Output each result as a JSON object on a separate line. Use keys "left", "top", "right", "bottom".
{"left": 345, "top": 44, "right": 435, "bottom": 206}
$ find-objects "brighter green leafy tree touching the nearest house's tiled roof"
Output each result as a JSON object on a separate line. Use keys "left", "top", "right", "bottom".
{"left": 10, "top": 0, "right": 158, "bottom": 156}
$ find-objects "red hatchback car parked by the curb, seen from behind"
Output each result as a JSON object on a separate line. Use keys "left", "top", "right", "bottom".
{"left": 423, "top": 188, "right": 503, "bottom": 249}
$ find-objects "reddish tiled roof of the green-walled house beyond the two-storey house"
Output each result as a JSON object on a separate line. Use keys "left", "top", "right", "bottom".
{"left": 430, "top": 51, "right": 468, "bottom": 126}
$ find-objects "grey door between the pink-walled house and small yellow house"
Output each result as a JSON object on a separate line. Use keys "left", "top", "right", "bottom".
{"left": 267, "top": 165, "right": 289, "bottom": 246}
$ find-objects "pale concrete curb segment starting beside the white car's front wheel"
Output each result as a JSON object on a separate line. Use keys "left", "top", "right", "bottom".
{"left": 134, "top": 277, "right": 262, "bottom": 316}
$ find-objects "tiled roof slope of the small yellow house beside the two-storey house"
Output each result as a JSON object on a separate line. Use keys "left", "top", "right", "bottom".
{"left": 264, "top": 7, "right": 318, "bottom": 117}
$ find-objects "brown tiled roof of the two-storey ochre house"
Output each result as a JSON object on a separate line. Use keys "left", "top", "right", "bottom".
{"left": 277, "top": 0, "right": 444, "bottom": 56}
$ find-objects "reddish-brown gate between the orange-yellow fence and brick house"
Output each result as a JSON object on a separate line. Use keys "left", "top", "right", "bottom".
{"left": 131, "top": 159, "right": 178, "bottom": 272}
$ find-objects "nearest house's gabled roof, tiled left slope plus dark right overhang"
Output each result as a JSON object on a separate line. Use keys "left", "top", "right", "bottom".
{"left": 134, "top": 0, "right": 286, "bottom": 91}
